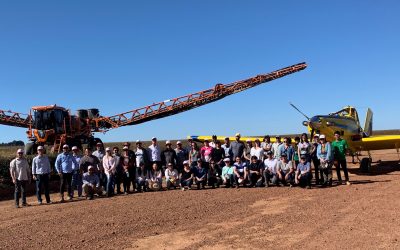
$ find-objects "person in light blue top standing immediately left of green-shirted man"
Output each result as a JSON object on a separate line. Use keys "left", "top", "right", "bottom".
{"left": 317, "top": 135, "right": 333, "bottom": 186}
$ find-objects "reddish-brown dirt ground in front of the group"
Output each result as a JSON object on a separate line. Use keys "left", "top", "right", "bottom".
{"left": 0, "top": 150, "right": 400, "bottom": 249}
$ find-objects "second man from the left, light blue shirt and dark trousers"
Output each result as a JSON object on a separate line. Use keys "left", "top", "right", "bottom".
{"left": 32, "top": 146, "right": 51, "bottom": 205}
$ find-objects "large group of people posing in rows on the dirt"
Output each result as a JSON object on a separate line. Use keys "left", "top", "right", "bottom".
{"left": 10, "top": 131, "right": 350, "bottom": 207}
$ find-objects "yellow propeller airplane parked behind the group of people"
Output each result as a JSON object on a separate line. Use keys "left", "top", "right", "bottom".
{"left": 189, "top": 104, "right": 400, "bottom": 171}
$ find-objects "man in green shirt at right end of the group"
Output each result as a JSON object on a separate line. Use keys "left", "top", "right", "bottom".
{"left": 331, "top": 131, "right": 350, "bottom": 185}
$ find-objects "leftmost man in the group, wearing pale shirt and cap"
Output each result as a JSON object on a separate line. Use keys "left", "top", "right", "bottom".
{"left": 10, "top": 149, "right": 31, "bottom": 208}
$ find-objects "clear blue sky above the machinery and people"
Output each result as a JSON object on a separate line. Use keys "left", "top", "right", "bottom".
{"left": 0, "top": 0, "right": 400, "bottom": 142}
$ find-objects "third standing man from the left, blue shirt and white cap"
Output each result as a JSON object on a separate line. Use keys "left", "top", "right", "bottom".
{"left": 55, "top": 144, "right": 79, "bottom": 202}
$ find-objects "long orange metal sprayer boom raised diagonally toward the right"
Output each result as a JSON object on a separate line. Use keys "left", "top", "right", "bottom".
{"left": 93, "top": 63, "right": 307, "bottom": 131}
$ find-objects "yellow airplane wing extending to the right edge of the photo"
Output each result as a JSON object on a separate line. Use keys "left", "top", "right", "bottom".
{"left": 349, "top": 135, "right": 400, "bottom": 151}
